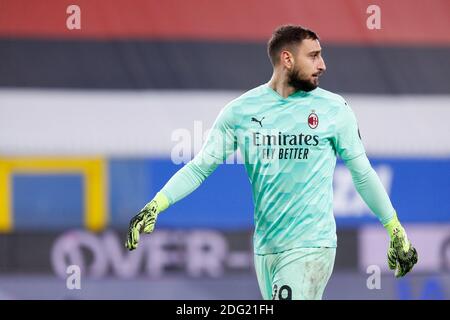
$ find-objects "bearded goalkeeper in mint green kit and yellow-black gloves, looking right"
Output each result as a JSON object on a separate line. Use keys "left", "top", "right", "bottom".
{"left": 125, "top": 25, "right": 417, "bottom": 299}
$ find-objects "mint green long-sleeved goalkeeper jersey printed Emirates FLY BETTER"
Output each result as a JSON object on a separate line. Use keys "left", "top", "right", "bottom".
{"left": 162, "top": 84, "right": 393, "bottom": 254}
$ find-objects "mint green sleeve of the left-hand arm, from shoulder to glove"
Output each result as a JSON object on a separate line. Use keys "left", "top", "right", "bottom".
{"left": 160, "top": 106, "right": 237, "bottom": 205}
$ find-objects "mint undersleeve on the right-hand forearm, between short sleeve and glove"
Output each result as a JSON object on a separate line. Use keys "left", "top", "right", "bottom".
{"left": 345, "top": 154, "right": 395, "bottom": 225}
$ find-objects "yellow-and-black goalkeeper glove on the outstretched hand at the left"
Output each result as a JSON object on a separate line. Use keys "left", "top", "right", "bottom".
{"left": 125, "top": 192, "right": 169, "bottom": 250}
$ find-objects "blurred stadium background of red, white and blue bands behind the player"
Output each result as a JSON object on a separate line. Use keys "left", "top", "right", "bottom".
{"left": 0, "top": 0, "right": 450, "bottom": 299}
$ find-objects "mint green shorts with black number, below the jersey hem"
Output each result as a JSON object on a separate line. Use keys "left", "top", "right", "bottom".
{"left": 255, "top": 248, "right": 336, "bottom": 300}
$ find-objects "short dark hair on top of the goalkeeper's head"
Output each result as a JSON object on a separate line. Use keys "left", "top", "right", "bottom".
{"left": 267, "top": 24, "right": 319, "bottom": 66}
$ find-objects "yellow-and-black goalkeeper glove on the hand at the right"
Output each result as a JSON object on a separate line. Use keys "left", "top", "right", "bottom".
{"left": 384, "top": 213, "right": 418, "bottom": 278}
